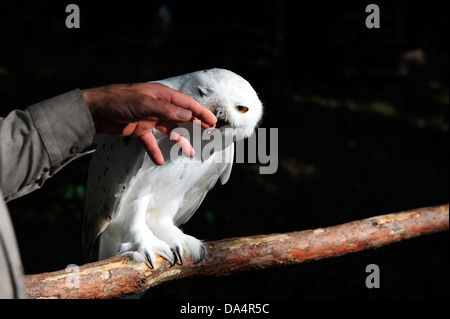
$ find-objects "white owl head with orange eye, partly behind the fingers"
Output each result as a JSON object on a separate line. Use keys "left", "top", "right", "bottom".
{"left": 174, "top": 69, "right": 263, "bottom": 140}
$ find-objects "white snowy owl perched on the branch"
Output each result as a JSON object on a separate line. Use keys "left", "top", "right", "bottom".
{"left": 83, "top": 69, "right": 262, "bottom": 268}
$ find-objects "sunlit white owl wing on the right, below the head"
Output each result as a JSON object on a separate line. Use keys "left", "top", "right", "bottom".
{"left": 174, "top": 144, "right": 234, "bottom": 226}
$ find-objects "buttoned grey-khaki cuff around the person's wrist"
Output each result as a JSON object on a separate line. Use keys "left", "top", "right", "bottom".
{"left": 28, "top": 89, "right": 95, "bottom": 167}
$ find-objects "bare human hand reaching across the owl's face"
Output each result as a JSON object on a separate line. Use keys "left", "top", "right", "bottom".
{"left": 81, "top": 83, "right": 217, "bottom": 165}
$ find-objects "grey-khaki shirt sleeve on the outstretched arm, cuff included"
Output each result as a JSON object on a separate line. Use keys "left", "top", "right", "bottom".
{"left": 0, "top": 89, "right": 95, "bottom": 201}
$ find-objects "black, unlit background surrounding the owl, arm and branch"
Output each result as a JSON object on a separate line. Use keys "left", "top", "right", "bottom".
{"left": 0, "top": 1, "right": 449, "bottom": 298}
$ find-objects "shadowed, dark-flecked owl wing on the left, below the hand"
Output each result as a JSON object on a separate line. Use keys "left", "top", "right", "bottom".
{"left": 83, "top": 134, "right": 145, "bottom": 256}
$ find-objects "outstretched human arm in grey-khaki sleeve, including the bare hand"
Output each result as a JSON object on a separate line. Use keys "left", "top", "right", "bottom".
{"left": 0, "top": 83, "right": 217, "bottom": 201}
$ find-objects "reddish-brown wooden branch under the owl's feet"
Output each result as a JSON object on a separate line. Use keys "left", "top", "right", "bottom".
{"left": 26, "top": 204, "right": 449, "bottom": 298}
